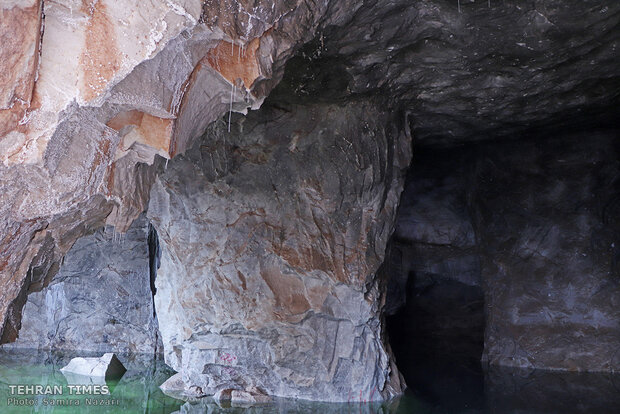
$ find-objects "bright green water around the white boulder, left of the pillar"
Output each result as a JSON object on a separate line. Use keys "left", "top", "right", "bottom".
{"left": 0, "top": 350, "right": 183, "bottom": 414}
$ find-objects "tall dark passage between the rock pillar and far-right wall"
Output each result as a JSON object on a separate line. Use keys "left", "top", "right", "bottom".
{"left": 383, "top": 149, "right": 484, "bottom": 410}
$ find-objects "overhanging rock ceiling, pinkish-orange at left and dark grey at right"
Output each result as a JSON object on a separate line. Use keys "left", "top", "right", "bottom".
{"left": 0, "top": 0, "right": 620, "bottom": 402}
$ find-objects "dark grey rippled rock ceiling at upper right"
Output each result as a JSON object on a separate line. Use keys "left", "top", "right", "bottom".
{"left": 318, "top": 0, "right": 620, "bottom": 147}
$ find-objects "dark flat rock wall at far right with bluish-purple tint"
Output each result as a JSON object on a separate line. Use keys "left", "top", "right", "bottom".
{"left": 473, "top": 133, "right": 620, "bottom": 371}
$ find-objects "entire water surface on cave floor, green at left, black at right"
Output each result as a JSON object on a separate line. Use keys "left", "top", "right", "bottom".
{"left": 0, "top": 351, "right": 620, "bottom": 414}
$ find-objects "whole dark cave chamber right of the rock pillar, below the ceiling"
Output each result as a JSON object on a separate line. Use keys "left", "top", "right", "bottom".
{"left": 383, "top": 129, "right": 620, "bottom": 412}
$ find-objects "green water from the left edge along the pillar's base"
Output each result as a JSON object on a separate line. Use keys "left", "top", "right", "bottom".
{"left": 0, "top": 350, "right": 413, "bottom": 414}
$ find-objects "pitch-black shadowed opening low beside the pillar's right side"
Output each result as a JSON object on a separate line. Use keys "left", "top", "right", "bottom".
{"left": 387, "top": 275, "right": 484, "bottom": 410}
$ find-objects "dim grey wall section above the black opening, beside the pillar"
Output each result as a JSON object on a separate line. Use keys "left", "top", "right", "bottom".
{"left": 383, "top": 148, "right": 482, "bottom": 314}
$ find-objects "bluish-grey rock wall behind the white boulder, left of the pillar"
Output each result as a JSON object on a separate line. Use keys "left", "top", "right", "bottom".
{"left": 4, "top": 215, "right": 161, "bottom": 354}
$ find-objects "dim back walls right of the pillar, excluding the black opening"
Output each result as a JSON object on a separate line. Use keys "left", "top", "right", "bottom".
{"left": 387, "top": 131, "right": 620, "bottom": 371}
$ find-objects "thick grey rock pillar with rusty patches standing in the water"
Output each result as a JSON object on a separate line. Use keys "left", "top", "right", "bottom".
{"left": 148, "top": 102, "right": 410, "bottom": 401}
